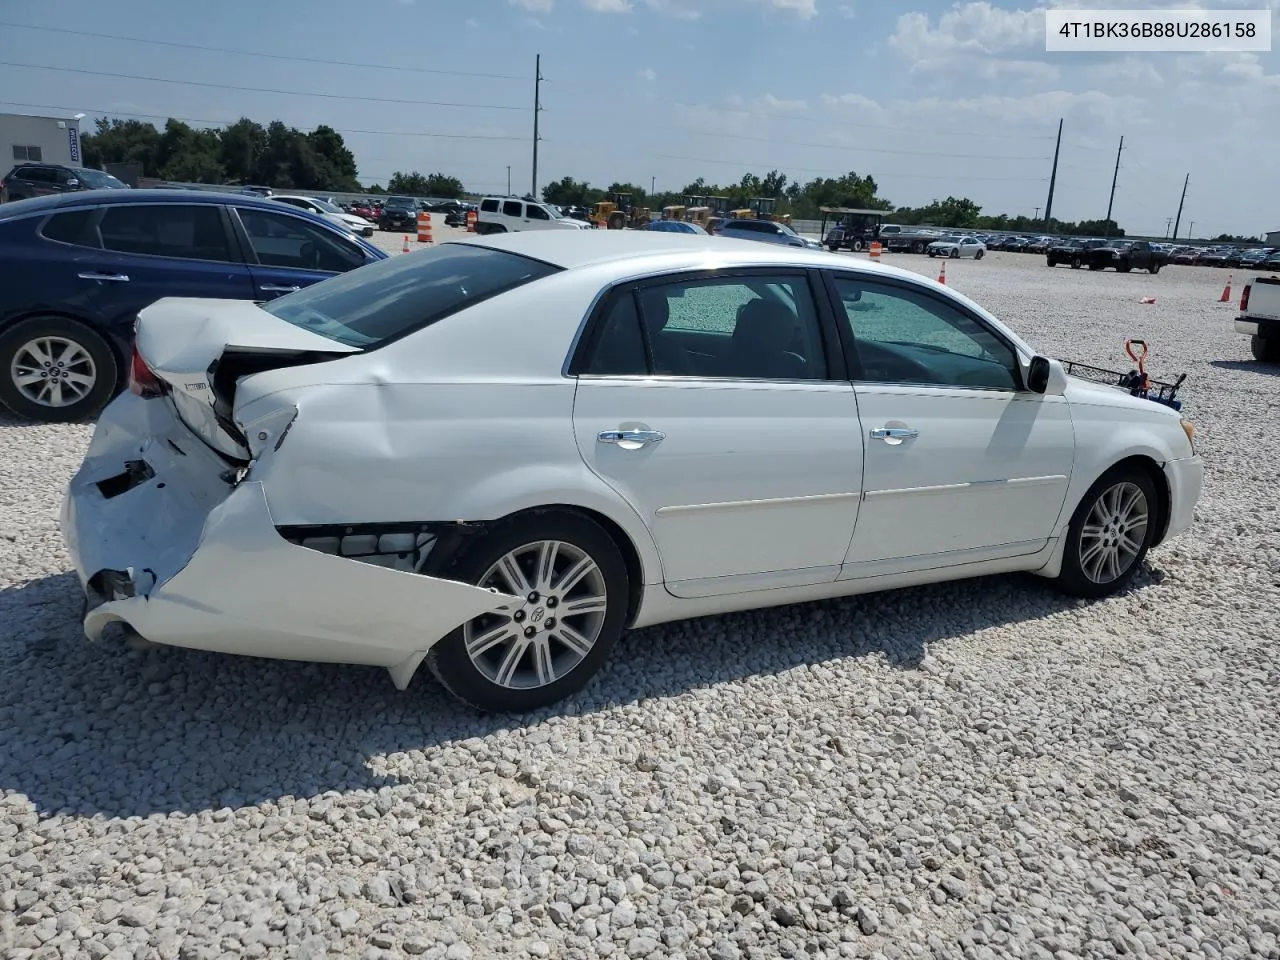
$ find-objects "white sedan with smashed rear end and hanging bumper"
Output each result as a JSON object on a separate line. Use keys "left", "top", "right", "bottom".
{"left": 61, "top": 230, "right": 1202, "bottom": 710}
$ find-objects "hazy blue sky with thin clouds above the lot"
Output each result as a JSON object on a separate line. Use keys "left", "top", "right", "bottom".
{"left": 0, "top": 0, "right": 1280, "bottom": 236}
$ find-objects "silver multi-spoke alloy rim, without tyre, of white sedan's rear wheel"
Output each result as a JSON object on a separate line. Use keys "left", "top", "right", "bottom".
{"left": 462, "top": 540, "right": 608, "bottom": 690}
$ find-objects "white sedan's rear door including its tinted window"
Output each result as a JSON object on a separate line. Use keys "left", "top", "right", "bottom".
{"left": 573, "top": 269, "right": 863, "bottom": 596}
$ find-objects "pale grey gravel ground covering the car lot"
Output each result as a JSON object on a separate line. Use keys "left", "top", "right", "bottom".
{"left": 0, "top": 249, "right": 1280, "bottom": 960}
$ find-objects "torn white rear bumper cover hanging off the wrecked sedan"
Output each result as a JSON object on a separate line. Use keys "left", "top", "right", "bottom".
{"left": 61, "top": 394, "right": 516, "bottom": 687}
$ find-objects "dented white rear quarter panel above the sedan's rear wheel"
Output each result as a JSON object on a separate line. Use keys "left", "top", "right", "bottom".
{"left": 236, "top": 270, "right": 662, "bottom": 584}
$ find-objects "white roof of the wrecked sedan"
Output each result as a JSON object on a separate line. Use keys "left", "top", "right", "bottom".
{"left": 447, "top": 230, "right": 920, "bottom": 282}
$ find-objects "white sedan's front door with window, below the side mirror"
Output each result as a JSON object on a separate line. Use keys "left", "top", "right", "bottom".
{"left": 833, "top": 274, "right": 1075, "bottom": 576}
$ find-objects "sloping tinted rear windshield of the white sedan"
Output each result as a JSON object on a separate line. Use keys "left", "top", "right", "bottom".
{"left": 262, "top": 243, "right": 559, "bottom": 347}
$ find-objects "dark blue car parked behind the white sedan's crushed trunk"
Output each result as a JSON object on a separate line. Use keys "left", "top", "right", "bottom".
{"left": 0, "top": 189, "right": 387, "bottom": 422}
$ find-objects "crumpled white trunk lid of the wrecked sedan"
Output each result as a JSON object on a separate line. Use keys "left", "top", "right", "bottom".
{"left": 134, "top": 297, "right": 360, "bottom": 462}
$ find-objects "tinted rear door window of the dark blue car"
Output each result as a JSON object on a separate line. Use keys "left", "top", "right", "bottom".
{"left": 99, "top": 204, "right": 232, "bottom": 261}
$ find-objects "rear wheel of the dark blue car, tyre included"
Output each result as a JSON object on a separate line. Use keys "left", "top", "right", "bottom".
{"left": 0, "top": 316, "right": 119, "bottom": 424}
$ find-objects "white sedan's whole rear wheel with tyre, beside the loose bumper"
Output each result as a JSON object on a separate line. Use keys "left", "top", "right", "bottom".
{"left": 426, "top": 511, "right": 630, "bottom": 713}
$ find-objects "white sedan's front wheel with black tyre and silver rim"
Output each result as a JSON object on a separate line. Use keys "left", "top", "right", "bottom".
{"left": 1057, "top": 466, "right": 1158, "bottom": 598}
